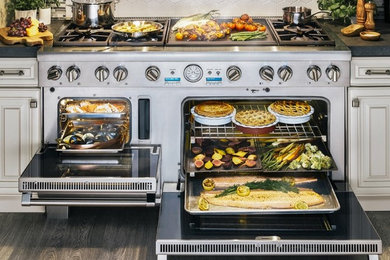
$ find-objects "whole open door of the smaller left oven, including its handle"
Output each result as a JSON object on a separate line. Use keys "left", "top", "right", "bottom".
{"left": 19, "top": 145, "right": 161, "bottom": 206}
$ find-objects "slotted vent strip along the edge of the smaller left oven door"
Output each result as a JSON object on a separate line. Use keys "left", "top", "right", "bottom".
{"left": 22, "top": 181, "right": 156, "bottom": 192}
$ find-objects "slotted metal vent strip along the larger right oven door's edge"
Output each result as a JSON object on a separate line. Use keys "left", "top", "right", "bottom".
{"left": 156, "top": 240, "right": 382, "bottom": 255}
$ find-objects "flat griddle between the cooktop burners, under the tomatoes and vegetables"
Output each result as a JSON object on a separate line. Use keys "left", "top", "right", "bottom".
{"left": 166, "top": 18, "right": 276, "bottom": 46}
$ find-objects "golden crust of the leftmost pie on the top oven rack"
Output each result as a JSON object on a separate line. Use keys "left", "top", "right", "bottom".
{"left": 194, "top": 101, "right": 234, "bottom": 117}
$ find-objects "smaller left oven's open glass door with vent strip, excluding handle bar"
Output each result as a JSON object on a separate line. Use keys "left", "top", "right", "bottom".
{"left": 19, "top": 145, "right": 160, "bottom": 192}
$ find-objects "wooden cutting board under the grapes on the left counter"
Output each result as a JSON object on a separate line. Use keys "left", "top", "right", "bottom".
{"left": 0, "top": 27, "right": 53, "bottom": 46}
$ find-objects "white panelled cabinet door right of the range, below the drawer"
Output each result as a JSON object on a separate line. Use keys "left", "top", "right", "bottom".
{"left": 348, "top": 87, "right": 390, "bottom": 210}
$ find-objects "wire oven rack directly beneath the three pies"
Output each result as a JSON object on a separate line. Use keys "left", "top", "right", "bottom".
{"left": 191, "top": 121, "right": 326, "bottom": 141}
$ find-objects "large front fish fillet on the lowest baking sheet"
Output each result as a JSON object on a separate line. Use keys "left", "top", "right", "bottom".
{"left": 201, "top": 189, "right": 325, "bottom": 209}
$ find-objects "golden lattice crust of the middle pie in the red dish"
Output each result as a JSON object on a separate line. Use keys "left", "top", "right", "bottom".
{"left": 234, "top": 109, "right": 276, "bottom": 126}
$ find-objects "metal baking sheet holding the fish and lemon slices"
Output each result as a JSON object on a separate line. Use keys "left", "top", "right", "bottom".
{"left": 184, "top": 172, "right": 340, "bottom": 215}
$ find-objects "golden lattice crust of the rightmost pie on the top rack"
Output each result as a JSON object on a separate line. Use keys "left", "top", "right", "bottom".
{"left": 270, "top": 100, "right": 311, "bottom": 116}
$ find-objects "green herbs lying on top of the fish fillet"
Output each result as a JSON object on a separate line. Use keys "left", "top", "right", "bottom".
{"left": 215, "top": 179, "right": 298, "bottom": 198}
